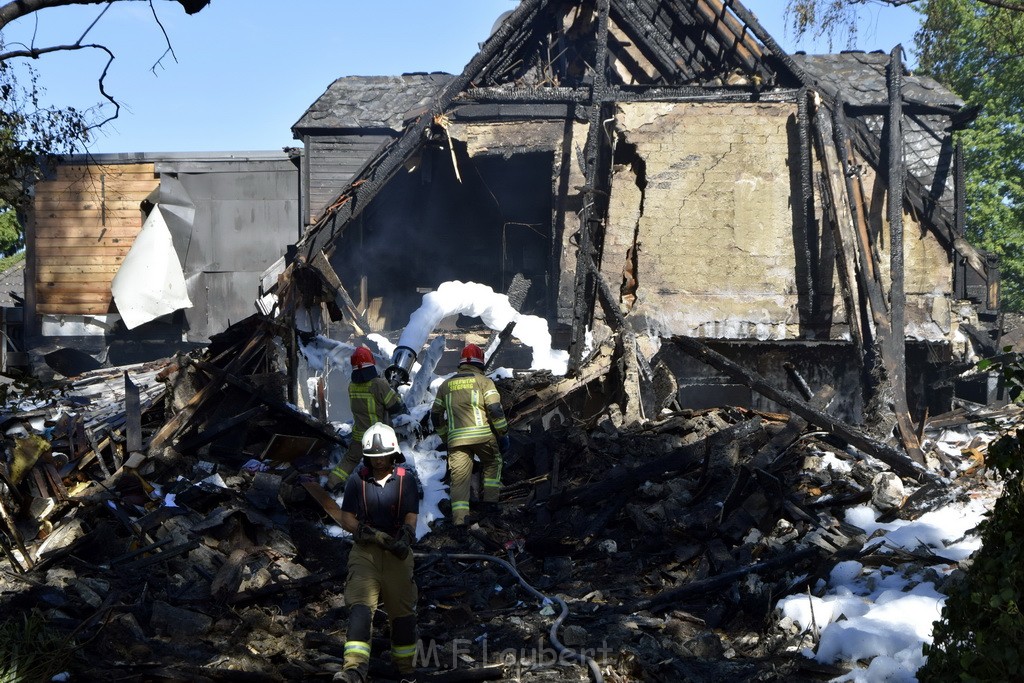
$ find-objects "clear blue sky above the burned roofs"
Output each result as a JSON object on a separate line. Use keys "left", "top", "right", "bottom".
{"left": 3, "top": 0, "right": 918, "bottom": 153}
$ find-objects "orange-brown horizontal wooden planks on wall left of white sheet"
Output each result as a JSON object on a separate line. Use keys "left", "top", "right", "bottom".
{"left": 33, "top": 163, "right": 160, "bottom": 315}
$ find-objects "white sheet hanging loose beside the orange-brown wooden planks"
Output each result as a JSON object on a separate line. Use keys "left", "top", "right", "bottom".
{"left": 111, "top": 206, "right": 191, "bottom": 330}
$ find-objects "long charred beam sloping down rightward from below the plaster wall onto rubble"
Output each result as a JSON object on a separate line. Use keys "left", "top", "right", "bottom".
{"left": 672, "top": 337, "right": 939, "bottom": 482}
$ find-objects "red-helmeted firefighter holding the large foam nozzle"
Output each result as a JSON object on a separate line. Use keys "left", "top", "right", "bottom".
{"left": 327, "top": 346, "right": 409, "bottom": 492}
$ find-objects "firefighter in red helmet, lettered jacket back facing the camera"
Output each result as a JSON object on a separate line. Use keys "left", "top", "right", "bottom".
{"left": 430, "top": 344, "right": 509, "bottom": 526}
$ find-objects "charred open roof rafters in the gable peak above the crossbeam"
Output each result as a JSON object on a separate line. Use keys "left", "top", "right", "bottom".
{"left": 473, "top": 0, "right": 792, "bottom": 87}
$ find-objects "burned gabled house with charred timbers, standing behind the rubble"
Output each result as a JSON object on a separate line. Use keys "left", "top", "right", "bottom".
{"left": 263, "top": 0, "right": 998, "bottom": 446}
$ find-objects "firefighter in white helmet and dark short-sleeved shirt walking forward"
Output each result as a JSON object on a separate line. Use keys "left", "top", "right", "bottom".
{"left": 334, "top": 423, "right": 420, "bottom": 683}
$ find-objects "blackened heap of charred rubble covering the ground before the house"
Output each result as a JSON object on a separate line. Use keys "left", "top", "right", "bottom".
{"left": 0, "top": 321, "right": 1007, "bottom": 681}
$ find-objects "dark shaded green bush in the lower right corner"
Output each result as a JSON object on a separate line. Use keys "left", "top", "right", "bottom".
{"left": 918, "top": 354, "right": 1024, "bottom": 683}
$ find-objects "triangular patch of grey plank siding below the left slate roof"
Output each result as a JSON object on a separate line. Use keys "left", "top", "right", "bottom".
{"left": 307, "top": 135, "right": 391, "bottom": 221}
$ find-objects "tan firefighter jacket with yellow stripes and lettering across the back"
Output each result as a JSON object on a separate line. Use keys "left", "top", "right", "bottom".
{"left": 430, "top": 362, "right": 509, "bottom": 449}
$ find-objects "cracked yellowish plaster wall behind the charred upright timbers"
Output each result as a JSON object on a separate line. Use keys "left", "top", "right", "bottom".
{"left": 601, "top": 102, "right": 955, "bottom": 341}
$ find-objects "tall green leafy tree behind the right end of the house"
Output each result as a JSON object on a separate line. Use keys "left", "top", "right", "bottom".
{"left": 915, "top": 0, "right": 1024, "bottom": 310}
